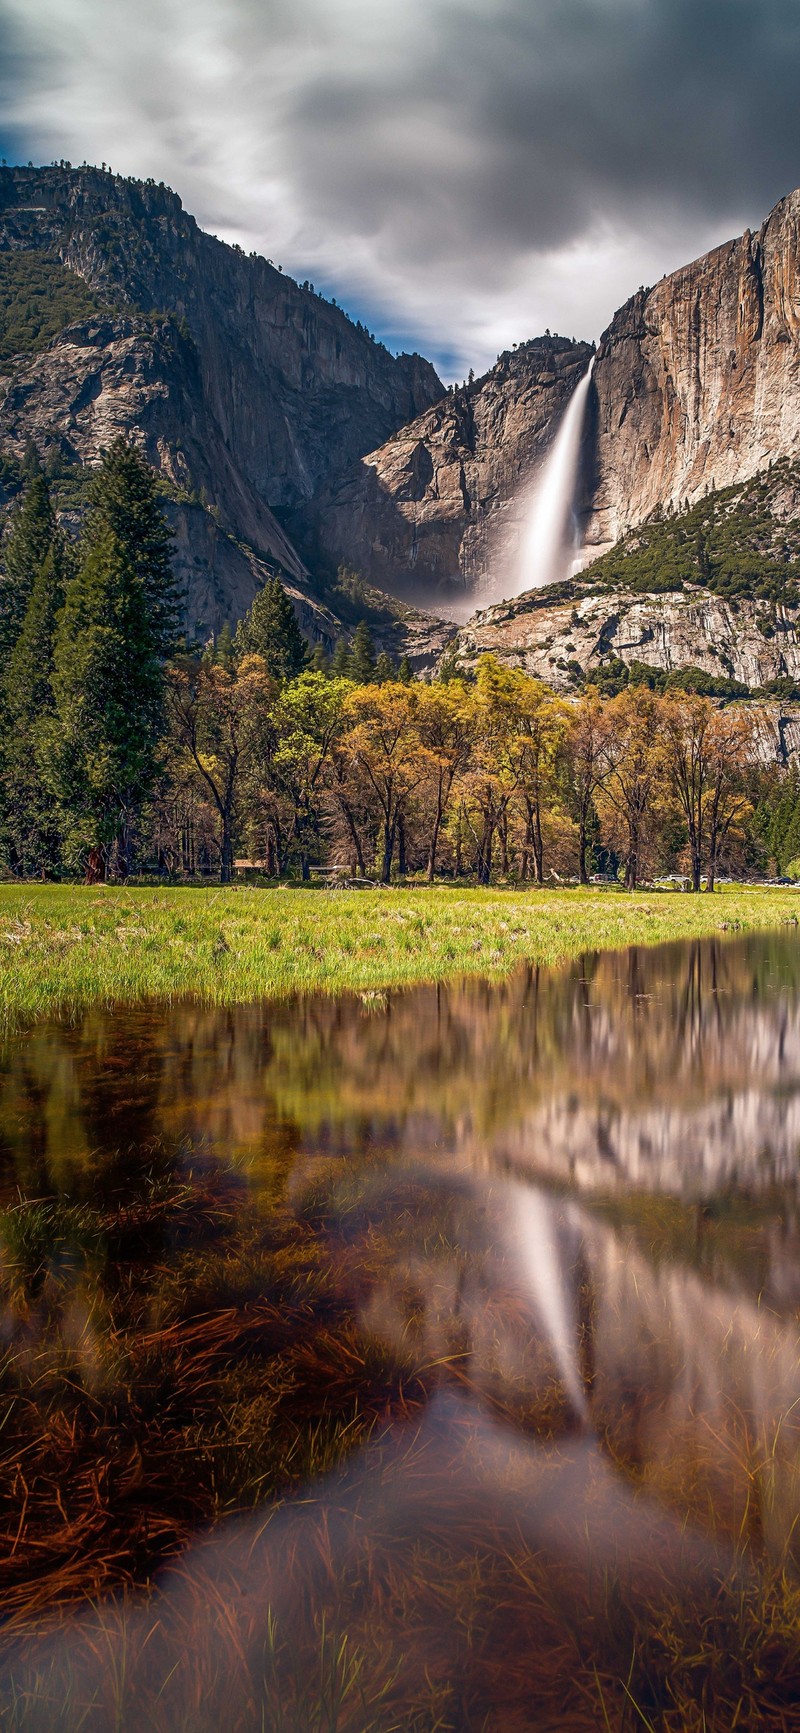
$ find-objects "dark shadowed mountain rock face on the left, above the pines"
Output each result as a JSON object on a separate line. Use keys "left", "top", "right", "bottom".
{"left": 0, "top": 168, "right": 443, "bottom": 627}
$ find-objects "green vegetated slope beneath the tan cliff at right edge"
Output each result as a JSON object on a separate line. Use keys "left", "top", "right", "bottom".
{"left": 585, "top": 459, "right": 800, "bottom": 607}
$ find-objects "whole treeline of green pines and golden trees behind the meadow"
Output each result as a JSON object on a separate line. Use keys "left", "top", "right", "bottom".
{"left": 0, "top": 440, "right": 800, "bottom": 889}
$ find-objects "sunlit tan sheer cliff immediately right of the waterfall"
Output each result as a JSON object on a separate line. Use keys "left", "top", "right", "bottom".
{"left": 582, "top": 192, "right": 800, "bottom": 549}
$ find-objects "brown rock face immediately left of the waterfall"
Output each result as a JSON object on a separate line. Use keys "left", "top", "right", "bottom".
{"left": 315, "top": 336, "right": 592, "bottom": 608}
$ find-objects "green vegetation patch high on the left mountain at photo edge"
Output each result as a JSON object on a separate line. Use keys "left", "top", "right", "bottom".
{"left": 0, "top": 253, "right": 107, "bottom": 362}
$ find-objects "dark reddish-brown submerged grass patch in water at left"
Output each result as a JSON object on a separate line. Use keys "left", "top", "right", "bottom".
{"left": 0, "top": 1173, "right": 429, "bottom": 1629}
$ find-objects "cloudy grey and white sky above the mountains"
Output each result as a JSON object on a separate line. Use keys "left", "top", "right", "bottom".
{"left": 0, "top": 0, "right": 800, "bottom": 378}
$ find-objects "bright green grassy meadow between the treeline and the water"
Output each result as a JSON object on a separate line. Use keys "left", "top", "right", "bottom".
{"left": 0, "top": 884, "right": 800, "bottom": 1017}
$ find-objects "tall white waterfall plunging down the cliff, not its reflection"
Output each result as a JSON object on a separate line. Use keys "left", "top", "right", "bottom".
{"left": 506, "top": 357, "right": 594, "bottom": 596}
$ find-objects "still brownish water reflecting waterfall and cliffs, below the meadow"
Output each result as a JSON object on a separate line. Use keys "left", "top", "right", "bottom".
{"left": 0, "top": 934, "right": 800, "bottom": 1733}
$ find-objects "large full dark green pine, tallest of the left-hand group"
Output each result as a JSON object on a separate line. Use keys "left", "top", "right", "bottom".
{"left": 43, "top": 440, "right": 177, "bottom": 877}
